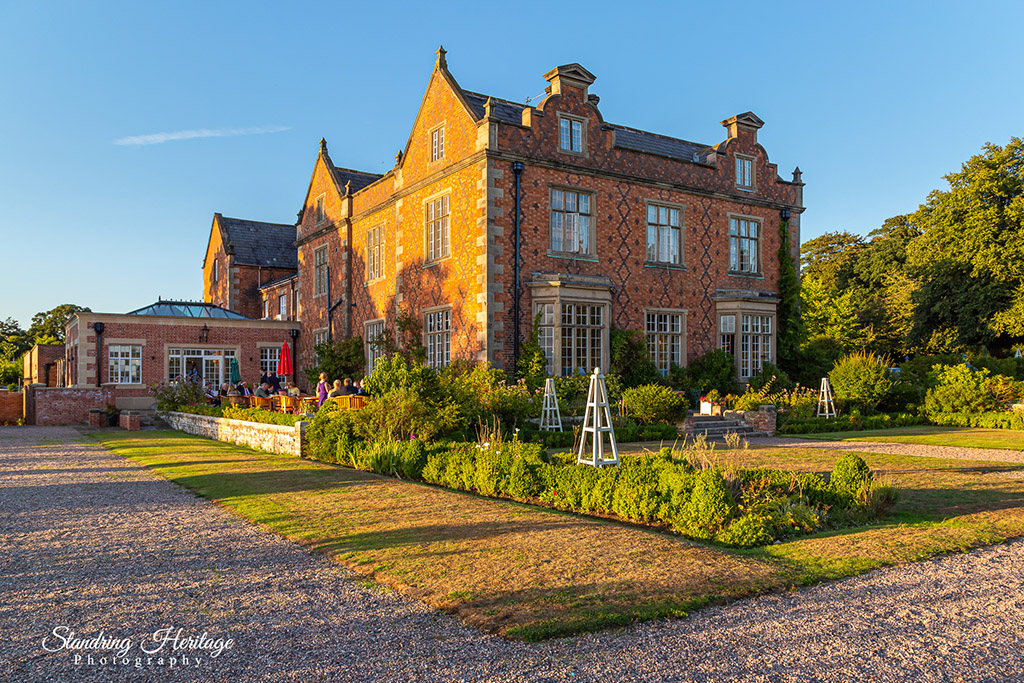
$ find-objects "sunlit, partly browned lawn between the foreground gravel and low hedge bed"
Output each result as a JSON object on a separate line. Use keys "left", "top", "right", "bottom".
{"left": 93, "top": 432, "right": 1024, "bottom": 639}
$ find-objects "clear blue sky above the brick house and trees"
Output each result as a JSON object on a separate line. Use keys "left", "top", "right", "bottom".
{"left": 0, "top": 0, "right": 1024, "bottom": 327}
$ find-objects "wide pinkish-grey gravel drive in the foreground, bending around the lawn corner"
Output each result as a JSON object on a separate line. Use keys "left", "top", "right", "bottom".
{"left": 6, "top": 427, "right": 1024, "bottom": 683}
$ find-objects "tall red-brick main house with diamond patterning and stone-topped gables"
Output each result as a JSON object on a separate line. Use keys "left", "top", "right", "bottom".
{"left": 288, "top": 50, "right": 803, "bottom": 385}
